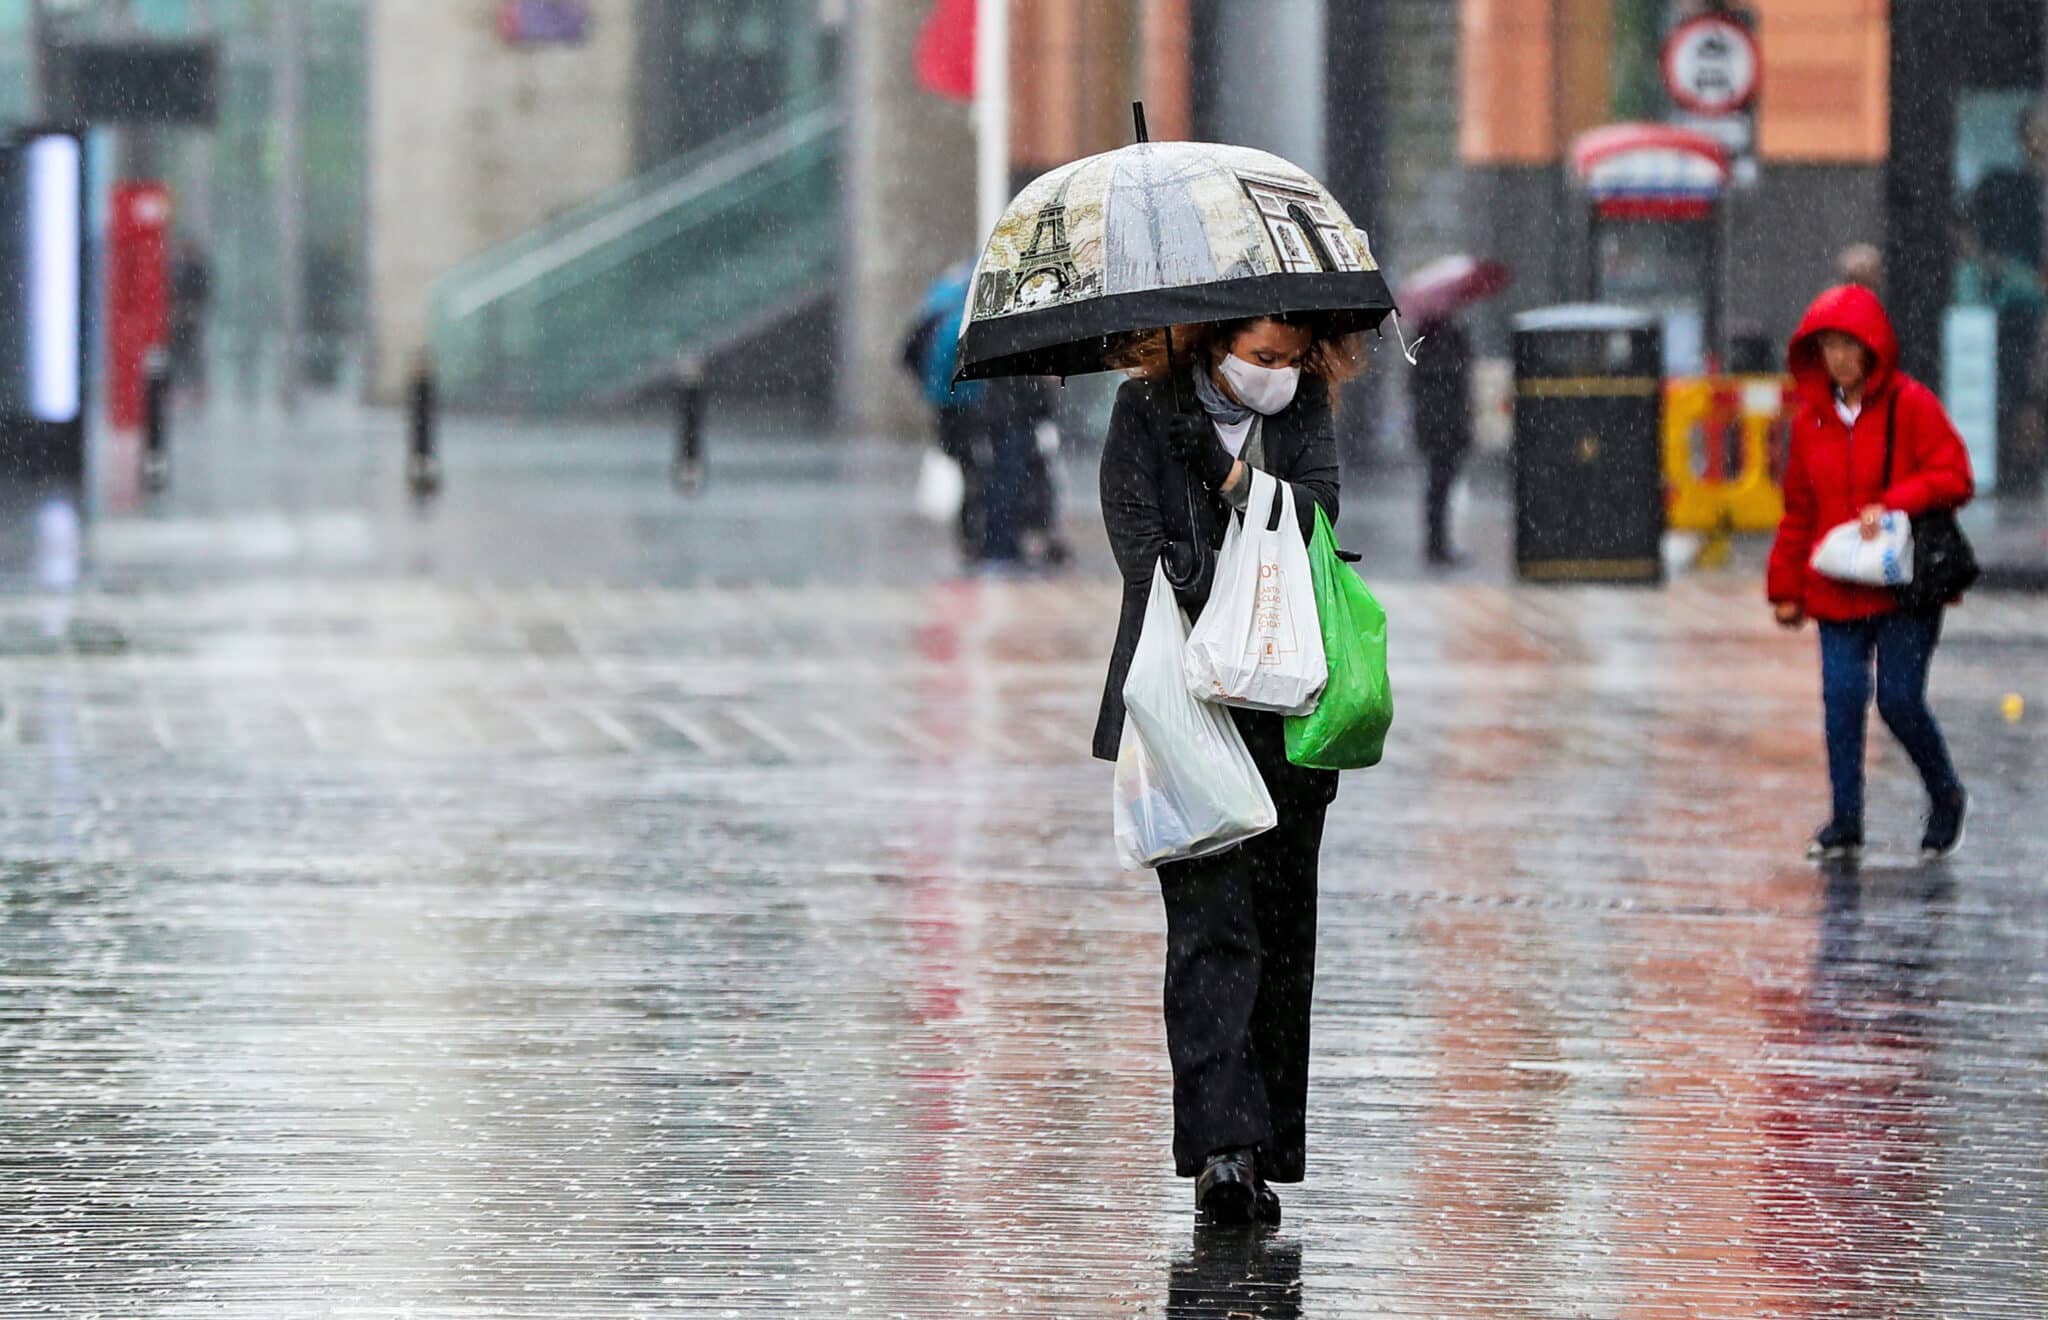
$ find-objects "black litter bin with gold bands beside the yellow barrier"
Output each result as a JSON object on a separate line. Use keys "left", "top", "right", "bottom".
{"left": 1513, "top": 305, "right": 1665, "bottom": 585}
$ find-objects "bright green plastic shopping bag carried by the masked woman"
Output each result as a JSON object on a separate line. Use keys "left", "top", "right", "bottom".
{"left": 1286, "top": 508, "right": 1395, "bottom": 769}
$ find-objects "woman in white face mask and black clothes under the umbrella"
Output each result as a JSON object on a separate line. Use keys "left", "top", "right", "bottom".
{"left": 1094, "top": 317, "right": 1358, "bottom": 1222}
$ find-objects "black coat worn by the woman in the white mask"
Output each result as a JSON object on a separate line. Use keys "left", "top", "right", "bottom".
{"left": 1094, "top": 377, "right": 1339, "bottom": 761}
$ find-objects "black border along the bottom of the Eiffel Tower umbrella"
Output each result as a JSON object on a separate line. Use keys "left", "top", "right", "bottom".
{"left": 952, "top": 270, "right": 1395, "bottom": 381}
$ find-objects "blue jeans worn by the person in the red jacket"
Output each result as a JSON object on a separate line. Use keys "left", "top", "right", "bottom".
{"left": 1821, "top": 610, "right": 1962, "bottom": 825}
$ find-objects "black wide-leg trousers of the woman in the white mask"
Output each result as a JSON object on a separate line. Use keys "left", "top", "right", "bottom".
{"left": 1159, "top": 712, "right": 1337, "bottom": 1183}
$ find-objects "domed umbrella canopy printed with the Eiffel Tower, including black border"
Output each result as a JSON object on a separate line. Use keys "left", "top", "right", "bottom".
{"left": 958, "top": 141, "right": 1393, "bottom": 381}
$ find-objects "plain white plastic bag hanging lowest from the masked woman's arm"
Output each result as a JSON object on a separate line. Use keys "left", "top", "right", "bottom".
{"left": 1114, "top": 552, "right": 1280, "bottom": 870}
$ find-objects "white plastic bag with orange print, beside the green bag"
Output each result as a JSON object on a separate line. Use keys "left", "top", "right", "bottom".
{"left": 1186, "top": 471, "right": 1329, "bottom": 714}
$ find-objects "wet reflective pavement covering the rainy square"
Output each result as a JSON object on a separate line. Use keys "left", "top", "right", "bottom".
{"left": 0, "top": 403, "right": 2048, "bottom": 1320}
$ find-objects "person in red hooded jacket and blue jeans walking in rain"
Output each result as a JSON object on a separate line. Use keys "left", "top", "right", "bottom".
{"left": 1769, "top": 284, "right": 1976, "bottom": 860}
